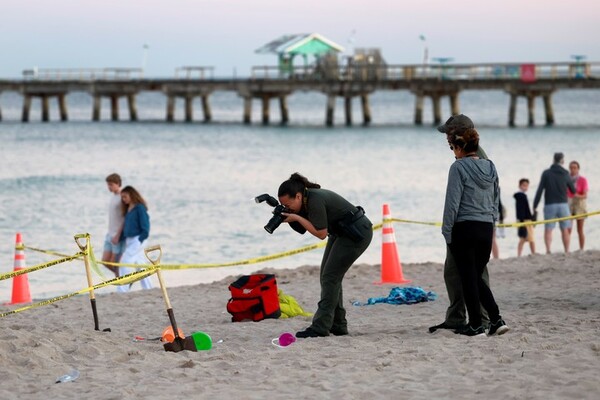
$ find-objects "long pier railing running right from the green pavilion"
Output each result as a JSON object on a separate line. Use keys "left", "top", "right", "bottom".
{"left": 251, "top": 63, "right": 600, "bottom": 81}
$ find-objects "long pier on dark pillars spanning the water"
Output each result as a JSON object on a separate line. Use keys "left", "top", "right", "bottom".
{"left": 0, "top": 62, "right": 600, "bottom": 126}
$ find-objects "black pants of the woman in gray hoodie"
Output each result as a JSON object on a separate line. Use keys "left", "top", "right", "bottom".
{"left": 450, "top": 221, "right": 500, "bottom": 328}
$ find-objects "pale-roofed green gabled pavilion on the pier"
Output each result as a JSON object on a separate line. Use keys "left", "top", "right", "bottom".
{"left": 256, "top": 33, "right": 344, "bottom": 75}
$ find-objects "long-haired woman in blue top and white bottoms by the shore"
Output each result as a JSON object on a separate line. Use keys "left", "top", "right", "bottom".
{"left": 117, "top": 186, "right": 152, "bottom": 292}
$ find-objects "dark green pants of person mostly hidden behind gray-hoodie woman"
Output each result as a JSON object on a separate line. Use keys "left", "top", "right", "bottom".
{"left": 444, "top": 245, "right": 490, "bottom": 327}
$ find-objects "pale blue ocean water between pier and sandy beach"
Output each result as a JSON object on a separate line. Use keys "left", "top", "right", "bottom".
{"left": 0, "top": 91, "right": 600, "bottom": 301}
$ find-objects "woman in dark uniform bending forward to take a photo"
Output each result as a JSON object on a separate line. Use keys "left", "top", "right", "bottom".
{"left": 277, "top": 173, "right": 373, "bottom": 338}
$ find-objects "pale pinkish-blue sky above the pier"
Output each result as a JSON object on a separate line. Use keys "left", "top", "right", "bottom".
{"left": 0, "top": 0, "right": 600, "bottom": 79}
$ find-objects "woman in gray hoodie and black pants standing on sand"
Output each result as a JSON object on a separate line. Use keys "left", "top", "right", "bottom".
{"left": 442, "top": 129, "right": 508, "bottom": 336}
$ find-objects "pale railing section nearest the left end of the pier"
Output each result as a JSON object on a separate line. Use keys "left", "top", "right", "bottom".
{"left": 23, "top": 68, "right": 144, "bottom": 81}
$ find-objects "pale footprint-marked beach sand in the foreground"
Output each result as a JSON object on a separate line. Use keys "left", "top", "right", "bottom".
{"left": 0, "top": 251, "right": 600, "bottom": 400}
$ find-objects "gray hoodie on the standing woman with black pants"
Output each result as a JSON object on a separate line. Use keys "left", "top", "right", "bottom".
{"left": 442, "top": 157, "right": 500, "bottom": 244}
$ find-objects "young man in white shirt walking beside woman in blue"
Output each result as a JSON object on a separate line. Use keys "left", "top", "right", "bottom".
{"left": 102, "top": 174, "right": 125, "bottom": 276}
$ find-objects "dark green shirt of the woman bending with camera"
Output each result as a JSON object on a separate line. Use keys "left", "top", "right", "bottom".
{"left": 306, "top": 189, "right": 356, "bottom": 231}
